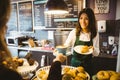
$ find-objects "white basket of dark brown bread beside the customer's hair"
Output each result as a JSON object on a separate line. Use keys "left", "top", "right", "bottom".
{"left": 13, "top": 53, "right": 39, "bottom": 77}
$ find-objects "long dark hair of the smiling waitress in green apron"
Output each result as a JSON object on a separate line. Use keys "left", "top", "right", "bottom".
{"left": 76, "top": 8, "right": 97, "bottom": 39}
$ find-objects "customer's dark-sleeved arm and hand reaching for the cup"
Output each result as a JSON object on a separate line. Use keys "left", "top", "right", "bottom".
{"left": 47, "top": 54, "right": 66, "bottom": 80}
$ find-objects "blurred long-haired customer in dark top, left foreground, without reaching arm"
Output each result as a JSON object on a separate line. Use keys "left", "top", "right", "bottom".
{"left": 0, "top": 0, "right": 22, "bottom": 80}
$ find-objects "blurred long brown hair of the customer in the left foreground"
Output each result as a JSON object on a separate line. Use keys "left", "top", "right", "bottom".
{"left": 0, "top": 0, "right": 12, "bottom": 69}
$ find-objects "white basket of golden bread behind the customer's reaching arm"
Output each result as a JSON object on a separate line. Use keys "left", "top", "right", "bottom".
{"left": 36, "top": 65, "right": 90, "bottom": 80}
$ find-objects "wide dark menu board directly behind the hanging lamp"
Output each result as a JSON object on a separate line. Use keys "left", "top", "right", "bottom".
{"left": 34, "top": 0, "right": 82, "bottom": 28}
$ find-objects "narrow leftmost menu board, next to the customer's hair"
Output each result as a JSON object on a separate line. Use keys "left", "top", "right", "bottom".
{"left": 7, "top": 3, "right": 18, "bottom": 32}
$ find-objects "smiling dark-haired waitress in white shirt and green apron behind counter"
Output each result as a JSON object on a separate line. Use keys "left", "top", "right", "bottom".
{"left": 64, "top": 8, "right": 99, "bottom": 75}
